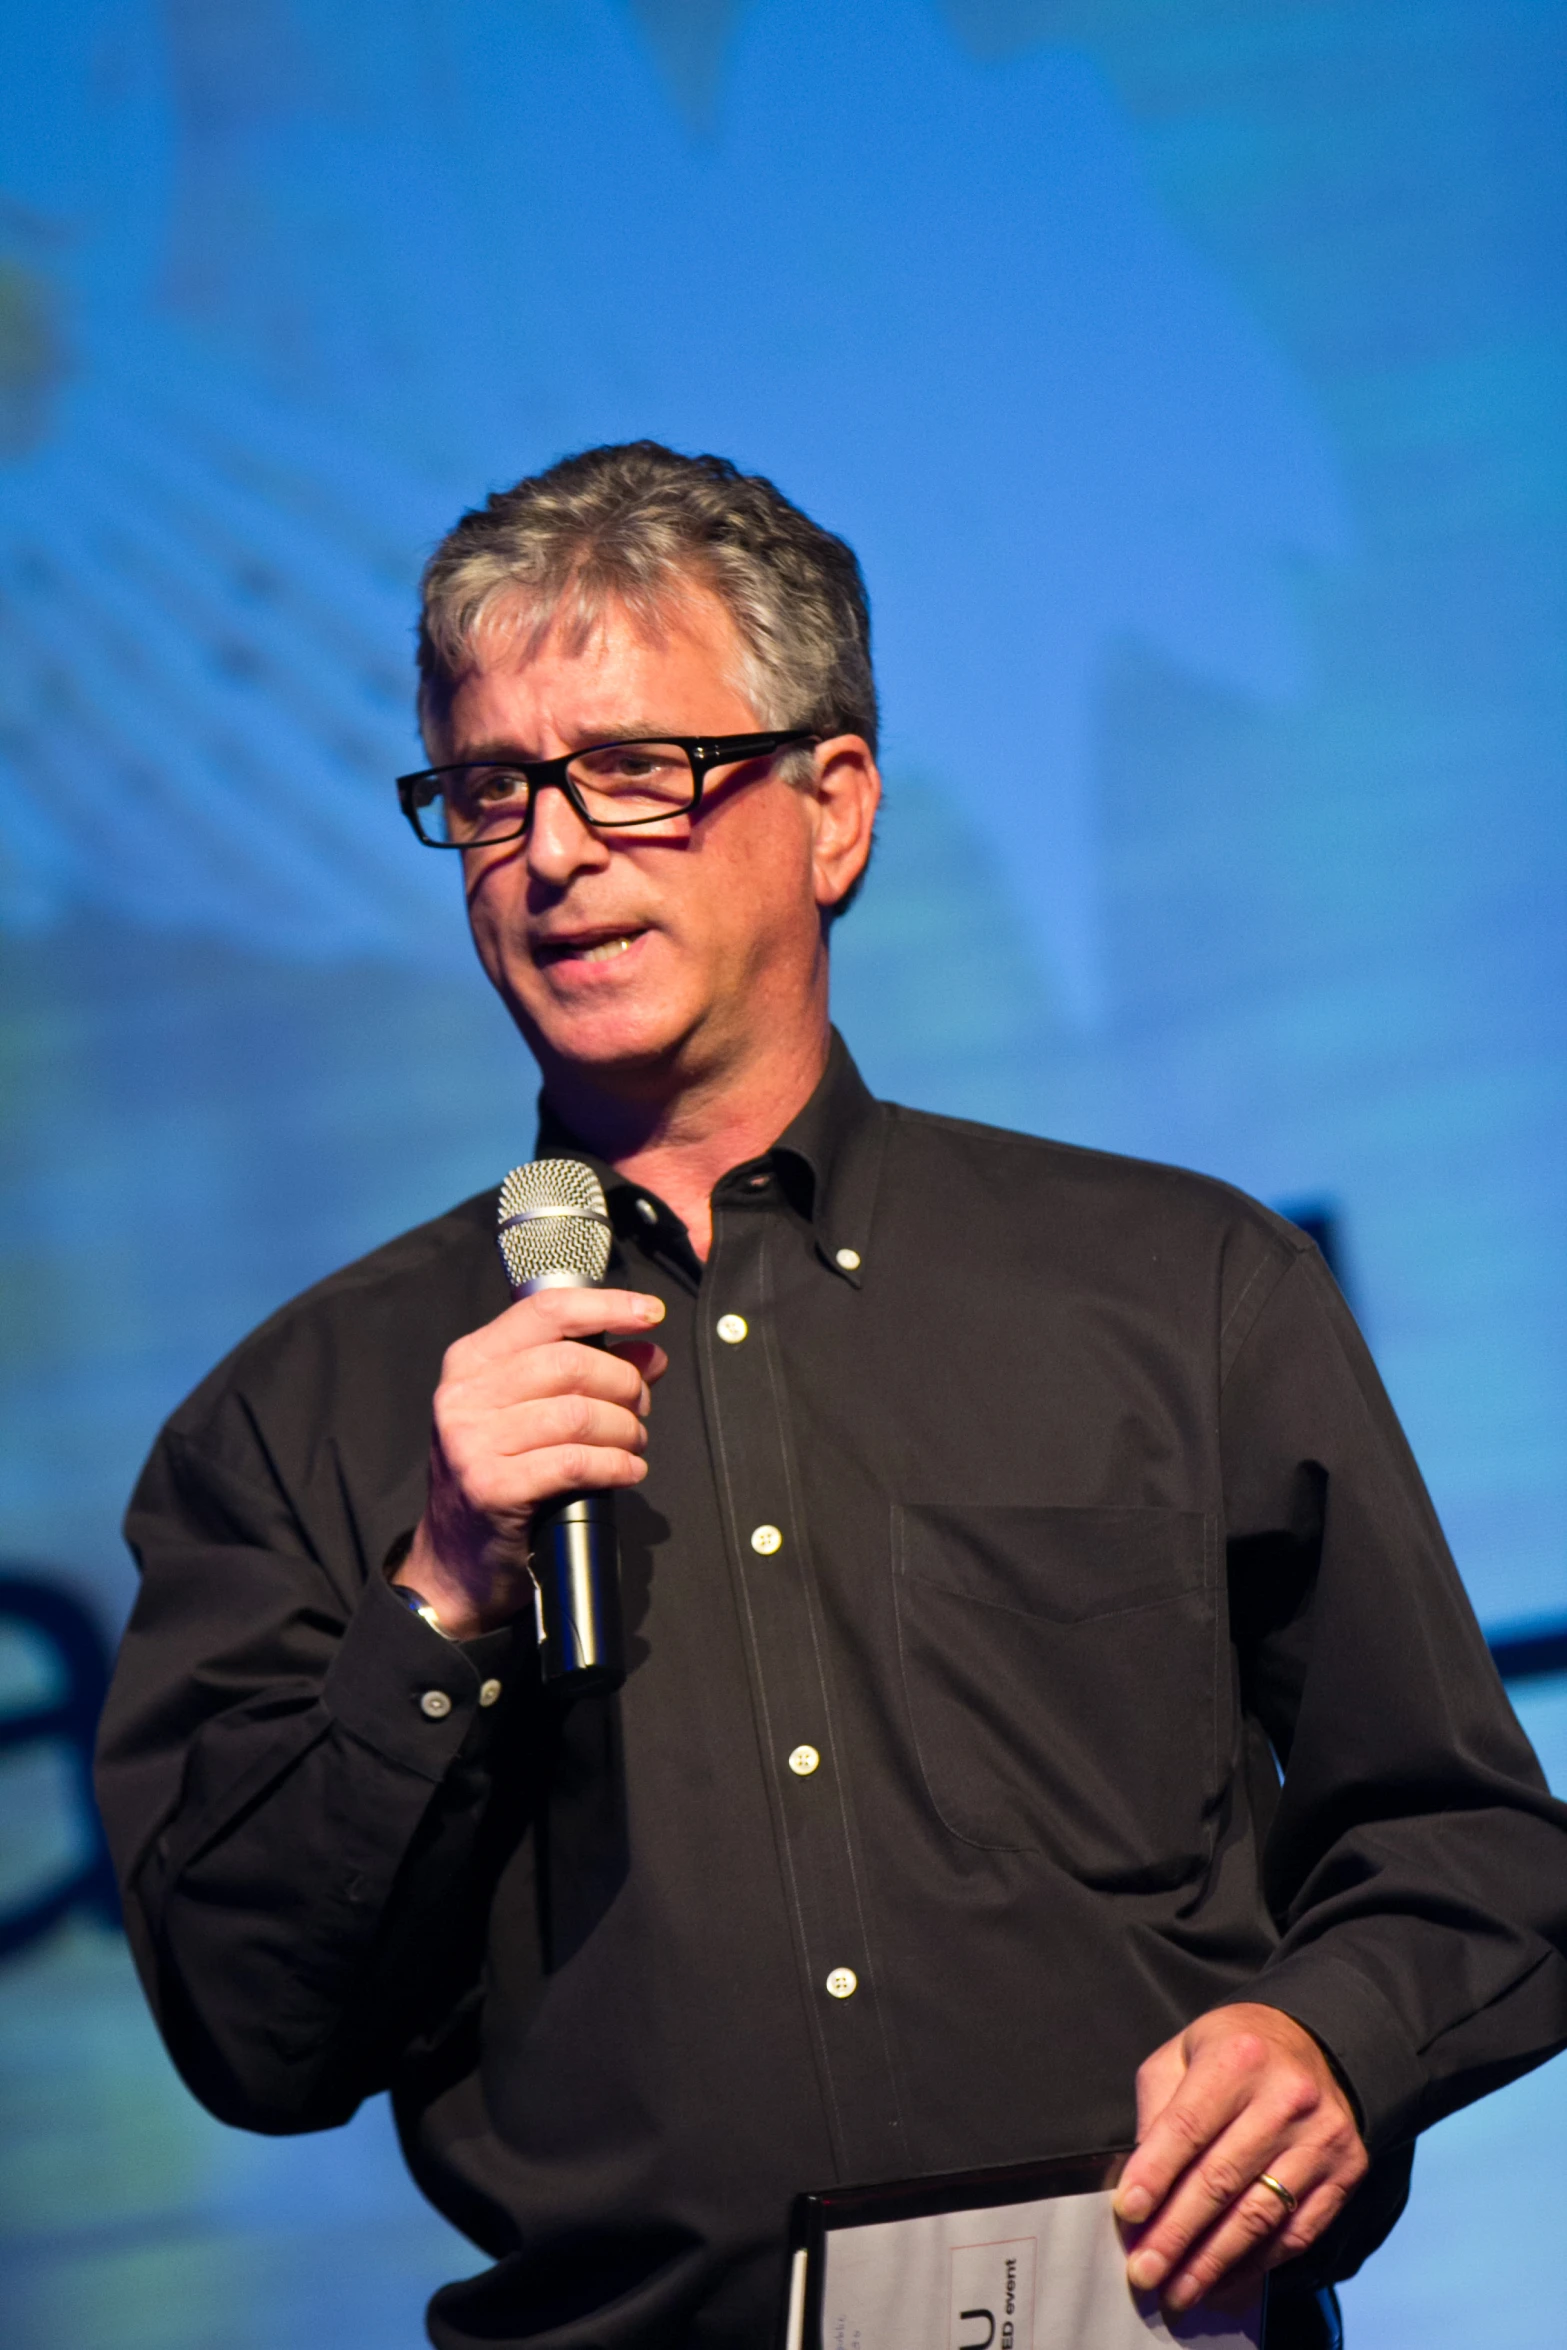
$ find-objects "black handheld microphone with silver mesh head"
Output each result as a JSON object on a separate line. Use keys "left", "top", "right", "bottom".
{"left": 498, "top": 1159, "right": 625, "bottom": 1697}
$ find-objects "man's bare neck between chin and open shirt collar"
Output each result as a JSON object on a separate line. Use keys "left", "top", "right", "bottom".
{"left": 547, "top": 1025, "right": 832, "bottom": 1262}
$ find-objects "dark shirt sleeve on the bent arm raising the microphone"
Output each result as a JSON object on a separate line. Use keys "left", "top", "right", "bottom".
{"left": 99, "top": 1398, "right": 533, "bottom": 2131}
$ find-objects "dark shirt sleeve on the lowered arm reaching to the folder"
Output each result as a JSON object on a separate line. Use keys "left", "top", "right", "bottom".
{"left": 1222, "top": 1250, "right": 1567, "bottom": 2150}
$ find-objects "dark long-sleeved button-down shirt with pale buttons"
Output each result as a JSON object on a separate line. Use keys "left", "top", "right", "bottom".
{"left": 101, "top": 1046, "right": 1567, "bottom": 2350}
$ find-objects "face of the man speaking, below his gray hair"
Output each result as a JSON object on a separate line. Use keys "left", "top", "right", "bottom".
{"left": 439, "top": 588, "right": 874, "bottom": 1090}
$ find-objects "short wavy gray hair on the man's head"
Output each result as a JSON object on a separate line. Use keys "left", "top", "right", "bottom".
{"left": 418, "top": 439, "right": 876, "bottom": 752}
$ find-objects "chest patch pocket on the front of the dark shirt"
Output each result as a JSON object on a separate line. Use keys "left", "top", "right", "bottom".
{"left": 893, "top": 1502, "right": 1219, "bottom": 1892}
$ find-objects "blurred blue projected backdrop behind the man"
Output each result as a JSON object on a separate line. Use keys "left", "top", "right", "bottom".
{"left": 0, "top": 0, "right": 1567, "bottom": 2350}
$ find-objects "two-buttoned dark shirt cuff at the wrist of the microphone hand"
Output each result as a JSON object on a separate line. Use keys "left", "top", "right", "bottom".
{"left": 324, "top": 1575, "right": 538, "bottom": 1781}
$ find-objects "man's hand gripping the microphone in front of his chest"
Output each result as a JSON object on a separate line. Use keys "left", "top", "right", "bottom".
{"left": 392, "top": 1290, "right": 667, "bottom": 1640}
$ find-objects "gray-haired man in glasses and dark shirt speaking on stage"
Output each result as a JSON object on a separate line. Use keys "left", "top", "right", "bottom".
{"left": 101, "top": 444, "right": 1567, "bottom": 2350}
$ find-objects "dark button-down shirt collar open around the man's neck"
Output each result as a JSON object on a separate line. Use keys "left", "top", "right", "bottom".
{"left": 533, "top": 1029, "right": 883, "bottom": 1288}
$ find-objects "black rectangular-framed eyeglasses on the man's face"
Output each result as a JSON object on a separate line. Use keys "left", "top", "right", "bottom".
{"left": 397, "top": 729, "right": 820, "bottom": 848}
